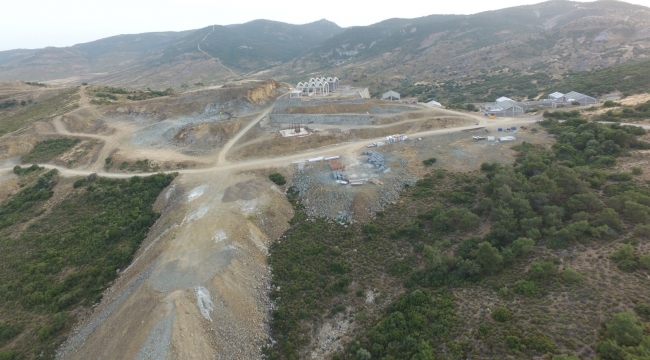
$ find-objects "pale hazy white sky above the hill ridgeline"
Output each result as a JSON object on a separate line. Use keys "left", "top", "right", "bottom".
{"left": 0, "top": 0, "right": 650, "bottom": 51}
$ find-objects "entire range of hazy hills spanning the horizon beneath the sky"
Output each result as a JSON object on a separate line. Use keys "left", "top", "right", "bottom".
{"left": 0, "top": 0, "right": 650, "bottom": 90}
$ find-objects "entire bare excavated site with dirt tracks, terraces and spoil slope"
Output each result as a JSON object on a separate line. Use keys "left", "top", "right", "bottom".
{"left": 0, "top": 80, "right": 568, "bottom": 359}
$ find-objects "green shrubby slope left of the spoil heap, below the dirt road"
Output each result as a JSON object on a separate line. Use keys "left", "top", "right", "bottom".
{"left": 0, "top": 170, "right": 174, "bottom": 359}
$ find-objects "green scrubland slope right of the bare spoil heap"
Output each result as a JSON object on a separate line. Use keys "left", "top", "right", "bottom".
{"left": 267, "top": 116, "right": 650, "bottom": 359}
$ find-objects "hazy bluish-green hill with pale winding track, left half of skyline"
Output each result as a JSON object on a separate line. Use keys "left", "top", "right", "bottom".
{"left": 0, "top": 20, "right": 342, "bottom": 87}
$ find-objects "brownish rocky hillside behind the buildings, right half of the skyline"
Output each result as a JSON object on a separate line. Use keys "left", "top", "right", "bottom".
{"left": 276, "top": 0, "right": 650, "bottom": 86}
